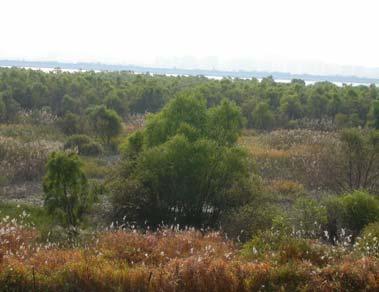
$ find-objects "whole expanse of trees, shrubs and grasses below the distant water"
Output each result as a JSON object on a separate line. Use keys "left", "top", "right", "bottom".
{"left": 0, "top": 69, "right": 379, "bottom": 291}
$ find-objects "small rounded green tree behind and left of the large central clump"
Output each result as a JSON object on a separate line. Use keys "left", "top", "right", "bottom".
{"left": 88, "top": 105, "right": 122, "bottom": 144}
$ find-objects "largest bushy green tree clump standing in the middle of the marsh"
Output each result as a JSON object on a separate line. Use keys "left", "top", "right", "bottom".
{"left": 112, "top": 95, "right": 253, "bottom": 226}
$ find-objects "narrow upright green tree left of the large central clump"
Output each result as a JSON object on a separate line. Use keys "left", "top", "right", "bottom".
{"left": 43, "top": 152, "right": 92, "bottom": 229}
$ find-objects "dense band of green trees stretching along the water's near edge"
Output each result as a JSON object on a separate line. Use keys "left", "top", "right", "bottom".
{"left": 0, "top": 68, "right": 379, "bottom": 130}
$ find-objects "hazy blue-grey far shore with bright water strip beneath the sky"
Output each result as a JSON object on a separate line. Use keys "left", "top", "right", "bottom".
{"left": 0, "top": 60, "right": 379, "bottom": 85}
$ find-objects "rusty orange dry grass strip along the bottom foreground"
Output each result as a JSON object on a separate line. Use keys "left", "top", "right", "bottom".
{"left": 0, "top": 222, "right": 379, "bottom": 291}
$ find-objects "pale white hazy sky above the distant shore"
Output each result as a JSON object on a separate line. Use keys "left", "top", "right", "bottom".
{"left": 0, "top": 0, "right": 379, "bottom": 76}
